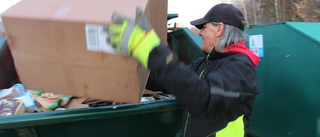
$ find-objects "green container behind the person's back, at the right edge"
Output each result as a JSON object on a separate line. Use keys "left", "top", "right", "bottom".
{"left": 246, "top": 22, "right": 320, "bottom": 137}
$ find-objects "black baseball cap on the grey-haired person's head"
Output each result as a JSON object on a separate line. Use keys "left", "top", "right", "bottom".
{"left": 190, "top": 3, "right": 244, "bottom": 30}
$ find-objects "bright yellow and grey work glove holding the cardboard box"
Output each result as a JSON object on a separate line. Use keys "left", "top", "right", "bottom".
{"left": 107, "top": 8, "right": 160, "bottom": 68}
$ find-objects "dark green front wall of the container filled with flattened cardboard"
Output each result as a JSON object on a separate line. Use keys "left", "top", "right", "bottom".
{"left": 0, "top": 100, "right": 182, "bottom": 137}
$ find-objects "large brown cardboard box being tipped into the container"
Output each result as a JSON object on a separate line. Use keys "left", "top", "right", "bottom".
{"left": 1, "top": 0, "right": 167, "bottom": 103}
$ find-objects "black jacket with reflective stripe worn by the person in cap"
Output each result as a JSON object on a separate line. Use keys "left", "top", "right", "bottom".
{"left": 146, "top": 42, "right": 258, "bottom": 137}
